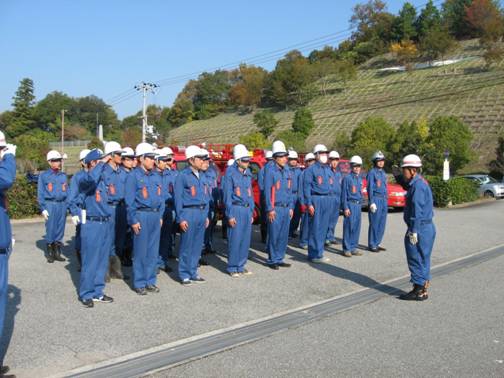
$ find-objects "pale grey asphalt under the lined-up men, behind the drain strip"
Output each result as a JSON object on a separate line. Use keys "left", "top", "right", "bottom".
{"left": 2, "top": 201, "right": 504, "bottom": 377}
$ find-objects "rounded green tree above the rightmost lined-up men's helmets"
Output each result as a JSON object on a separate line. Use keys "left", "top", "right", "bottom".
{"left": 350, "top": 118, "right": 395, "bottom": 167}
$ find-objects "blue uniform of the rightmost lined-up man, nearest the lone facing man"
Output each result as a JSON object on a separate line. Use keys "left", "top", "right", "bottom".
{"left": 367, "top": 167, "right": 388, "bottom": 249}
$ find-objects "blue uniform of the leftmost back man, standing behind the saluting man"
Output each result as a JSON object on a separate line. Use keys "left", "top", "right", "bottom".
{"left": 37, "top": 169, "right": 68, "bottom": 244}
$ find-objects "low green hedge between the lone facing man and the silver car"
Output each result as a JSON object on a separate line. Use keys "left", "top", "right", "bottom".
{"left": 426, "top": 176, "right": 479, "bottom": 207}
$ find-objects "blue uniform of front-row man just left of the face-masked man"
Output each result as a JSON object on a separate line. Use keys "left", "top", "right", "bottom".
{"left": 264, "top": 162, "right": 294, "bottom": 265}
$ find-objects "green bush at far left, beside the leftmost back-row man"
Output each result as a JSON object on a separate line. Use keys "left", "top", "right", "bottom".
{"left": 7, "top": 175, "right": 40, "bottom": 219}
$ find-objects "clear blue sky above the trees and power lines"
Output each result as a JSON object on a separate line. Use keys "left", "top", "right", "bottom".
{"left": 0, "top": 0, "right": 426, "bottom": 118}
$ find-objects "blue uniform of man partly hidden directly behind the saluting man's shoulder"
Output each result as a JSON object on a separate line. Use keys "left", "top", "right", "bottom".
{"left": 103, "top": 164, "right": 127, "bottom": 256}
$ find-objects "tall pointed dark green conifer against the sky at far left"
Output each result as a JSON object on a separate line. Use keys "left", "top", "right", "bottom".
{"left": 6, "top": 78, "right": 36, "bottom": 137}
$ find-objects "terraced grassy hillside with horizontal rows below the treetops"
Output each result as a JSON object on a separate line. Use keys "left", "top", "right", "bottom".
{"left": 170, "top": 40, "right": 504, "bottom": 169}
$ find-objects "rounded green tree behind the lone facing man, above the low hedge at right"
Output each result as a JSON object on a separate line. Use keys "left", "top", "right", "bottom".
{"left": 423, "top": 117, "right": 473, "bottom": 175}
